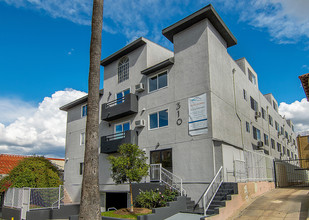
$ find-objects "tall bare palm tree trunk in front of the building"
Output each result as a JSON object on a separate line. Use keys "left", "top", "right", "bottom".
{"left": 79, "top": 0, "right": 104, "bottom": 220}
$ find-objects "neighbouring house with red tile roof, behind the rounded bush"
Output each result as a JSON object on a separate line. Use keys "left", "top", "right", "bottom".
{"left": 0, "top": 154, "right": 64, "bottom": 179}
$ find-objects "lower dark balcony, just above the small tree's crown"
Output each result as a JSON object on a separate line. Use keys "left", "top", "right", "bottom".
{"left": 101, "top": 130, "right": 137, "bottom": 154}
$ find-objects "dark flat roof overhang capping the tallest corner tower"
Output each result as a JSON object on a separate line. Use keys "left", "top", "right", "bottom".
{"left": 162, "top": 4, "right": 237, "bottom": 47}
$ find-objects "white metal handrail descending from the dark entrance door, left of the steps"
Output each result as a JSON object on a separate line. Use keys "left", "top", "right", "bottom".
{"left": 150, "top": 164, "right": 186, "bottom": 196}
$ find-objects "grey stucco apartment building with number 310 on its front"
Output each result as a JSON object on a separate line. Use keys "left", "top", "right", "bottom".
{"left": 61, "top": 5, "right": 298, "bottom": 210}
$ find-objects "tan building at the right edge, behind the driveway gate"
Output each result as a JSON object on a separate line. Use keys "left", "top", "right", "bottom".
{"left": 297, "top": 131, "right": 309, "bottom": 170}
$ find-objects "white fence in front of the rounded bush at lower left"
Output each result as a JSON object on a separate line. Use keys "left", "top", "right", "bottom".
{"left": 3, "top": 186, "right": 64, "bottom": 211}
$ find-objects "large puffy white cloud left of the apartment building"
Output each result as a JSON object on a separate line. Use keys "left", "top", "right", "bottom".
{"left": 0, "top": 89, "right": 86, "bottom": 157}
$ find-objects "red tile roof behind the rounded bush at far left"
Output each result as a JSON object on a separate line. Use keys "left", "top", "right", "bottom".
{"left": 0, "top": 154, "right": 64, "bottom": 174}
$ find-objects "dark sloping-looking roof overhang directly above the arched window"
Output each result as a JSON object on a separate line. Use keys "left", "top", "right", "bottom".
{"left": 101, "top": 37, "right": 147, "bottom": 66}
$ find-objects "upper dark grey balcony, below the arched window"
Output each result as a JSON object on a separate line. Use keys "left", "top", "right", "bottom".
{"left": 101, "top": 93, "right": 138, "bottom": 121}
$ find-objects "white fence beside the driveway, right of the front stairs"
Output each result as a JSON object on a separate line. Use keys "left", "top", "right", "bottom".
{"left": 234, "top": 151, "right": 274, "bottom": 182}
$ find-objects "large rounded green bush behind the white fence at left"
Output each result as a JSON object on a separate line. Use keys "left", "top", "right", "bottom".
{"left": 0, "top": 156, "right": 62, "bottom": 191}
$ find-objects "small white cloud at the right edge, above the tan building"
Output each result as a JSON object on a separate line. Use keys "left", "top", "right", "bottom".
{"left": 279, "top": 98, "right": 309, "bottom": 132}
